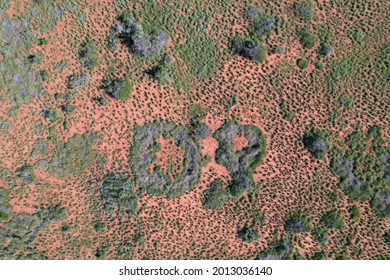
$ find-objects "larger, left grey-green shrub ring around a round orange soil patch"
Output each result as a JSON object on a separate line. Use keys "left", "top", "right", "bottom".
{"left": 130, "top": 122, "right": 201, "bottom": 198}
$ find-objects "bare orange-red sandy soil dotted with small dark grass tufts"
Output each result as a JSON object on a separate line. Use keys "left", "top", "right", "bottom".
{"left": 0, "top": 0, "right": 390, "bottom": 259}
